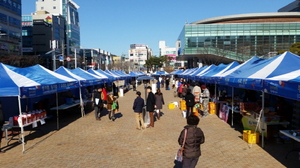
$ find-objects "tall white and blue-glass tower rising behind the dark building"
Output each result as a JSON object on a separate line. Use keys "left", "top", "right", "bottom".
{"left": 36, "top": 0, "right": 80, "bottom": 56}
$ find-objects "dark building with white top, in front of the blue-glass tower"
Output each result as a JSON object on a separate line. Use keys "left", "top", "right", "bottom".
{"left": 22, "top": 11, "right": 66, "bottom": 69}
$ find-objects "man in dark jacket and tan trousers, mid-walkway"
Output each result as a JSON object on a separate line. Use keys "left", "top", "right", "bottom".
{"left": 133, "top": 91, "right": 145, "bottom": 130}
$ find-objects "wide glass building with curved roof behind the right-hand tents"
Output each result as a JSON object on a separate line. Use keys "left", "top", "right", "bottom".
{"left": 177, "top": 12, "right": 300, "bottom": 66}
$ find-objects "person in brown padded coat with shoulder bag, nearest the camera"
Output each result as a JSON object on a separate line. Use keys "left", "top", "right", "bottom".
{"left": 178, "top": 115, "right": 205, "bottom": 168}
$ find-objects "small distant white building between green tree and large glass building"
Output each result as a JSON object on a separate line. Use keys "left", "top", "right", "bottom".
{"left": 158, "top": 41, "right": 184, "bottom": 68}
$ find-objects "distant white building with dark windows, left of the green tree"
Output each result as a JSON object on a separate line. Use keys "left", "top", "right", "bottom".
{"left": 128, "top": 44, "right": 152, "bottom": 70}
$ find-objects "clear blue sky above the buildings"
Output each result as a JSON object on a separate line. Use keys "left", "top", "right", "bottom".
{"left": 22, "top": 0, "right": 294, "bottom": 55}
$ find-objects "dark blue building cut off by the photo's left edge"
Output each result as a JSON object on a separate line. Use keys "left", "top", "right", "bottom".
{"left": 0, "top": 0, "right": 22, "bottom": 56}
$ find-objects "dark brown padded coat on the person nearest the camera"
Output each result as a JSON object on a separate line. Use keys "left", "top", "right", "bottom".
{"left": 178, "top": 125, "right": 205, "bottom": 158}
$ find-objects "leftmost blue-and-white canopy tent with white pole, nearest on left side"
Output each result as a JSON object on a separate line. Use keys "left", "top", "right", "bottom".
{"left": 0, "top": 63, "right": 41, "bottom": 152}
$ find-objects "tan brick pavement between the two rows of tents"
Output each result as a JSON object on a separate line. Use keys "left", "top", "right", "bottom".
{"left": 0, "top": 83, "right": 298, "bottom": 168}
